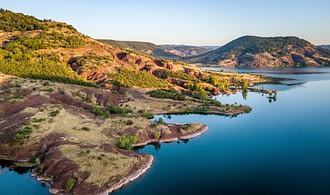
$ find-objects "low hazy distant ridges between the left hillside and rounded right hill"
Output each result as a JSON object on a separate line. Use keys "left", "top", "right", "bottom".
{"left": 99, "top": 39, "right": 218, "bottom": 59}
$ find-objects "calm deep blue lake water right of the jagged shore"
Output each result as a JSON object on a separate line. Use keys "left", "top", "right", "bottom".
{"left": 114, "top": 69, "right": 330, "bottom": 195}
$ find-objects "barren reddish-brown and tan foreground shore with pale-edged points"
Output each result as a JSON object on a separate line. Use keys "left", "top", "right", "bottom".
{"left": 0, "top": 74, "right": 255, "bottom": 194}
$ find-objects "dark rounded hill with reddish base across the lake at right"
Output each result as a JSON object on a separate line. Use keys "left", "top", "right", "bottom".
{"left": 183, "top": 36, "right": 330, "bottom": 68}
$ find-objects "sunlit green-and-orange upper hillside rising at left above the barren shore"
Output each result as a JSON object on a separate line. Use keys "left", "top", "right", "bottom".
{"left": 0, "top": 10, "right": 196, "bottom": 86}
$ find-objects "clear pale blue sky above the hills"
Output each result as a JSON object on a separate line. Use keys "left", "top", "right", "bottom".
{"left": 0, "top": 0, "right": 330, "bottom": 45}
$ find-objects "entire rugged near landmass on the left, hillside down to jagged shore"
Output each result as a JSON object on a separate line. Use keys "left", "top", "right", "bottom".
{"left": 0, "top": 9, "right": 268, "bottom": 194}
